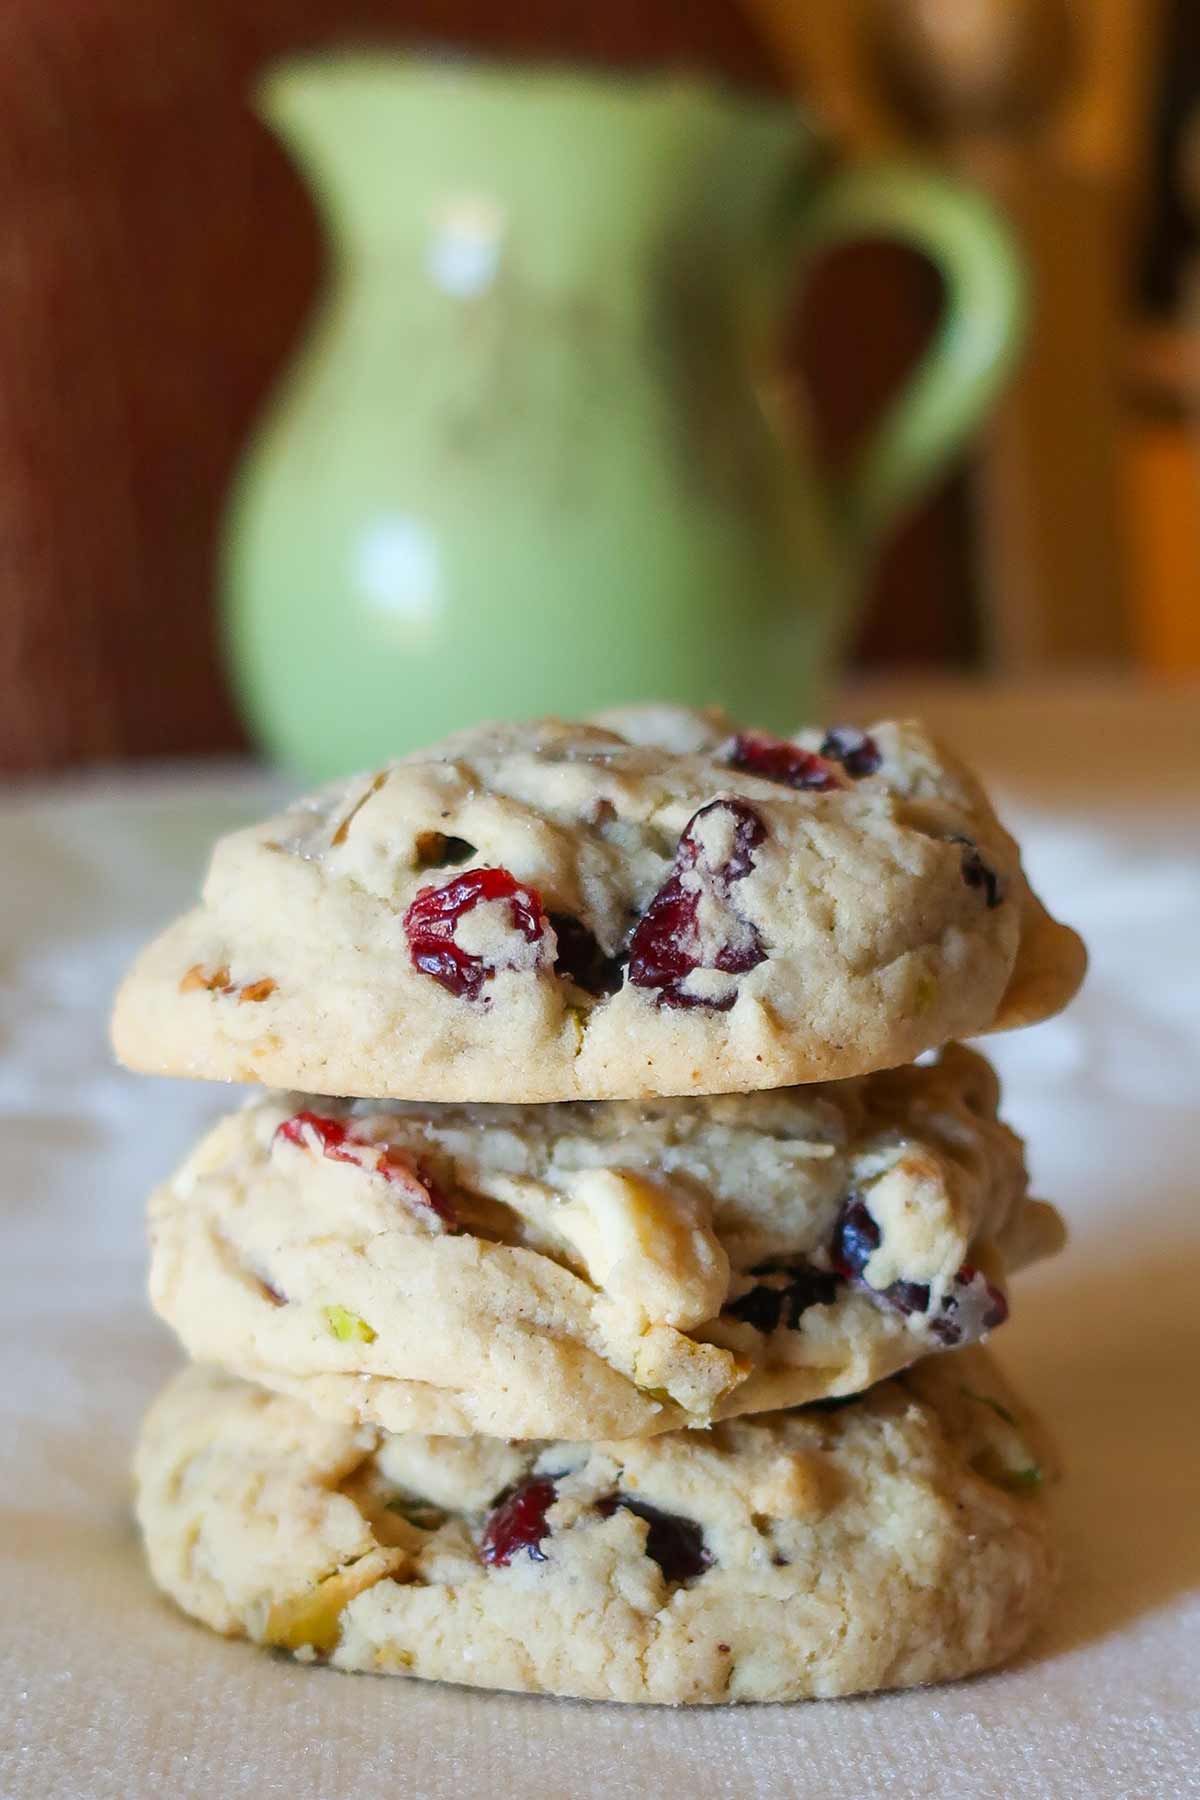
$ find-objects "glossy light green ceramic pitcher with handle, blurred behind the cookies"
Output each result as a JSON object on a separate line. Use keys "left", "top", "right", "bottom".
{"left": 225, "top": 54, "right": 1022, "bottom": 776}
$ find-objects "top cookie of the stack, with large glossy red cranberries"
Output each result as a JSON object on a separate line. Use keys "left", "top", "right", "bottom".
{"left": 113, "top": 707, "right": 1085, "bottom": 1102}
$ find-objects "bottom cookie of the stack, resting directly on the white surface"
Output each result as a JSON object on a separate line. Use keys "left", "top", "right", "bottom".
{"left": 135, "top": 1350, "right": 1054, "bottom": 1705}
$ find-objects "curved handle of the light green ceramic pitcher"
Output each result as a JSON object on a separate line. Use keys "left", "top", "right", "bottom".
{"left": 790, "top": 162, "right": 1027, "bottom": 545}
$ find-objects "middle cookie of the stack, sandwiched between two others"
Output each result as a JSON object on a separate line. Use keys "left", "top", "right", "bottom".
{"left": 149, "top": 1046, "right": 1061, "bottom": 1438}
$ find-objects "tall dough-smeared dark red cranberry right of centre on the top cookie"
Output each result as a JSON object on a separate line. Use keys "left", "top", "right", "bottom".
{"left": 630, "top": 799, "right": 766, "bottom": 1012}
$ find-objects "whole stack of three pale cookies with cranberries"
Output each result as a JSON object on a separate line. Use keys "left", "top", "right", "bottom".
{"left": 113, "top": 707, "right": 1083, "bottom": 1703}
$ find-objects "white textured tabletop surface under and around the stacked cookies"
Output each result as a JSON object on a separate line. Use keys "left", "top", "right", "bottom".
{"left": 0, "top": 689, "right": 1200, "bottom": 1800}
